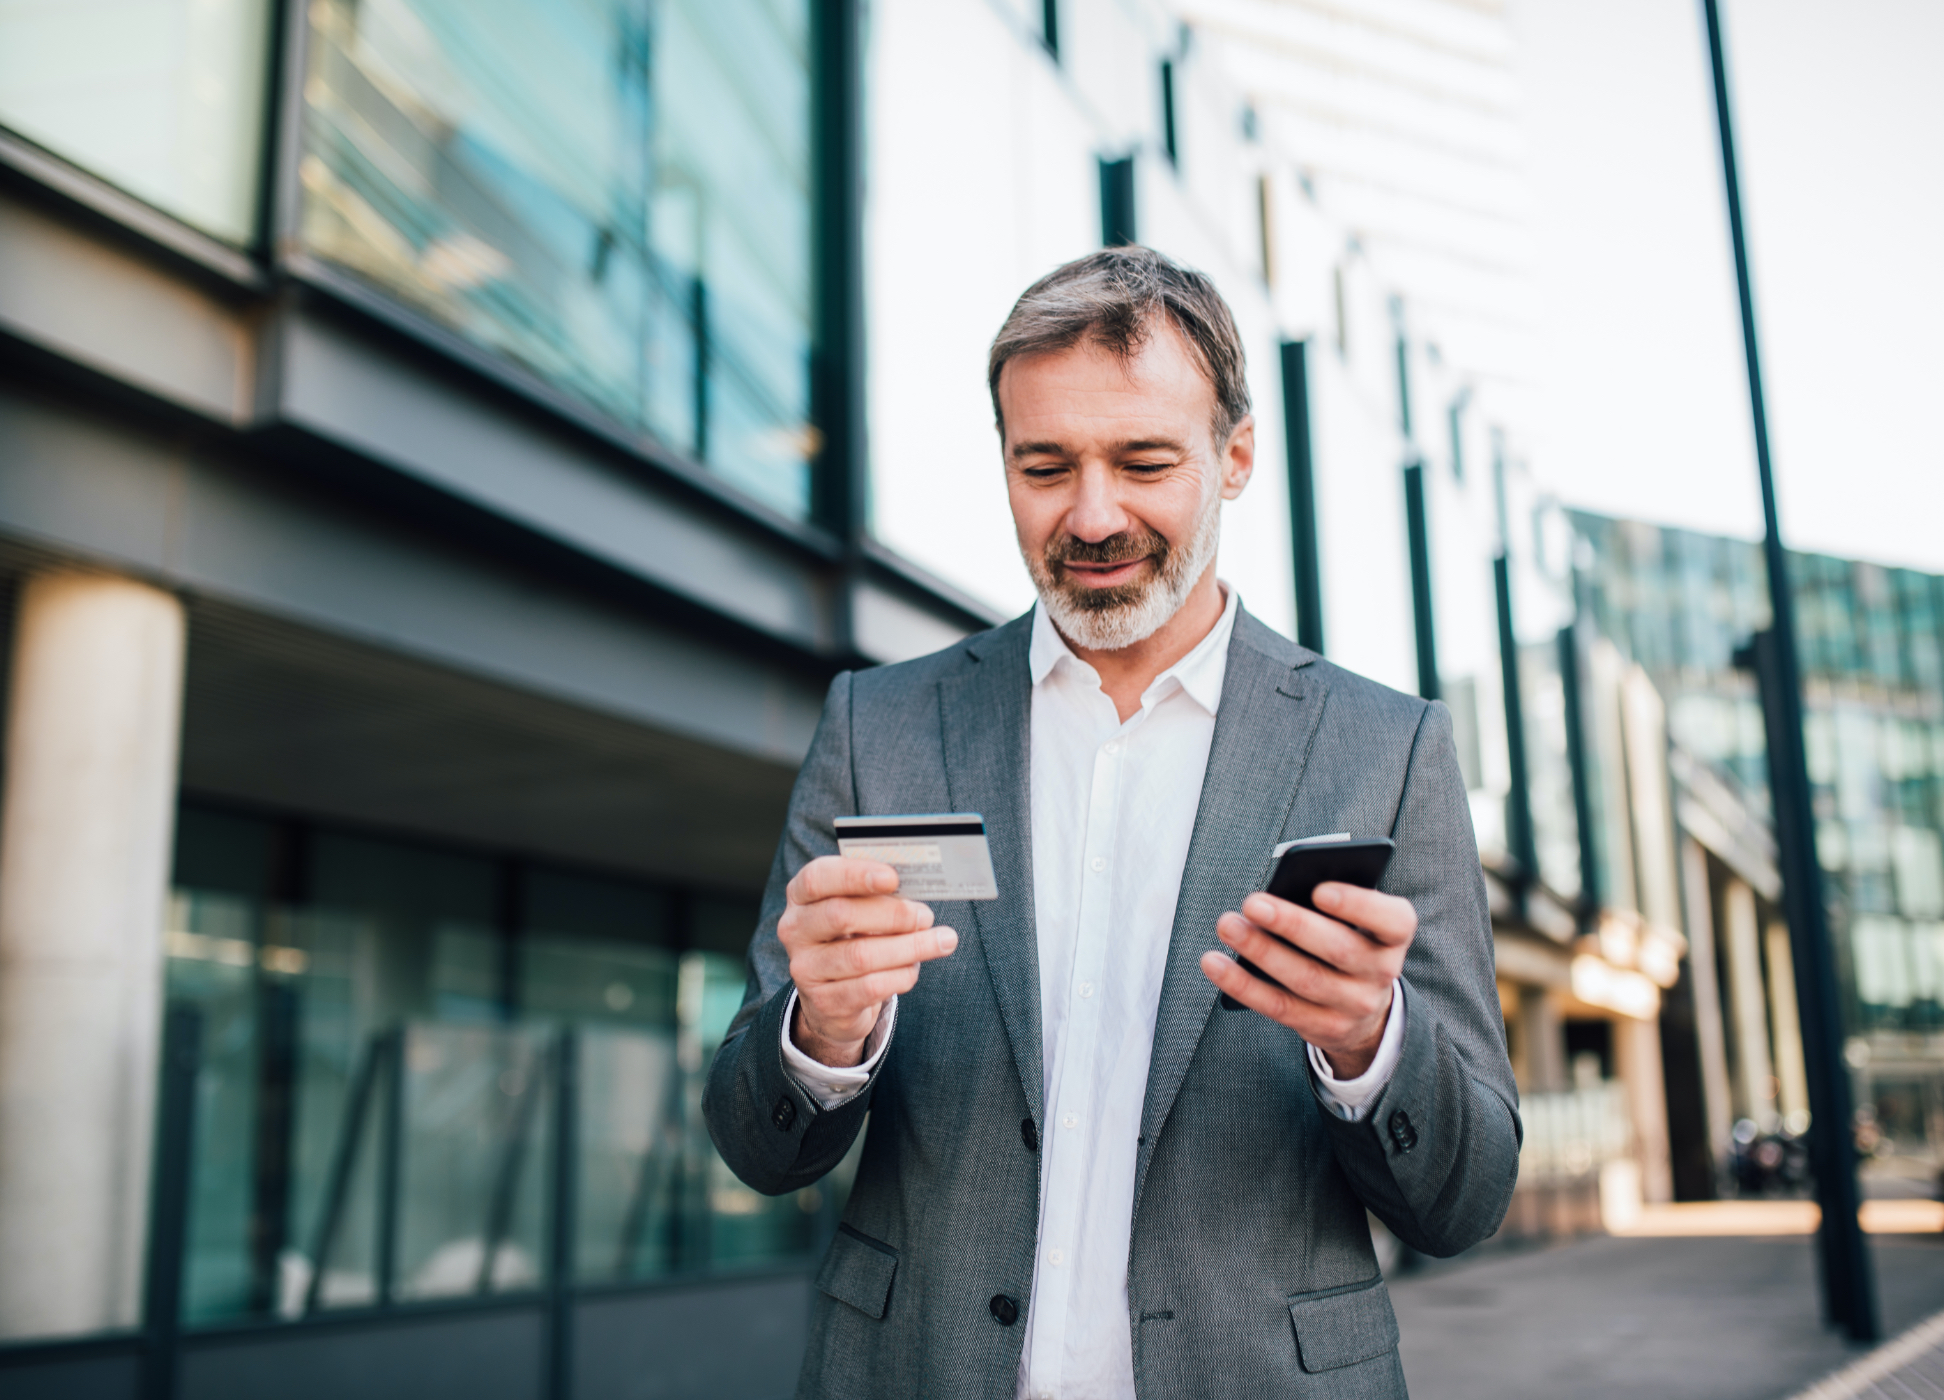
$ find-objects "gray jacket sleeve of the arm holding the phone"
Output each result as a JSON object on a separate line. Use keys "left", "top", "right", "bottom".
{"left": 1322, "top": 704, "right": 1520, "bottom": 1258}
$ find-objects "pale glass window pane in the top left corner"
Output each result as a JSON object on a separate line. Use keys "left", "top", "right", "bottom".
{"left": 0, "top": 0, "right": 270, "bottom": 243}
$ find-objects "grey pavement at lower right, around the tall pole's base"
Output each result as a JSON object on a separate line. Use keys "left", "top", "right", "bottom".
{"left": 1392, "top": 1235, "right": 1944, "bottom": 1400}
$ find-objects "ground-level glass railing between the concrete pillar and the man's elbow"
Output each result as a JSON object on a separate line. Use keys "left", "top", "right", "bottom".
{"left": 179, "top": 1003, "right": 851, "bottom": 1324}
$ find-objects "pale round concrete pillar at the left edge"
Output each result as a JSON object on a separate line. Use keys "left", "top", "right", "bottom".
{"left": 0, "top": 572, "right": 185, "bottom": 1338}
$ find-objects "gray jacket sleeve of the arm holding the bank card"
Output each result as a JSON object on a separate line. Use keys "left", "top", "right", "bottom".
{"left": 702, "top": 671, "right": 896, "bottom": 1196}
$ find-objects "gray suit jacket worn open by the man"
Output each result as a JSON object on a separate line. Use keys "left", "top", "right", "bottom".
{"left": 704, "top": 613, "right": 1520, "bottom": 1400}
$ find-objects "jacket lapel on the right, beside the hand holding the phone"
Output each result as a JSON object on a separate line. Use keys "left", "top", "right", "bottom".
{"left": 1135, "top": 613, "right": 1326, "bottom": 1174}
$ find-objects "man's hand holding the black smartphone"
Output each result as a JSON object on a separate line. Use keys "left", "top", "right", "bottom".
{"left": 1201, "top": 881, "right": 1417, "bottom": 1079}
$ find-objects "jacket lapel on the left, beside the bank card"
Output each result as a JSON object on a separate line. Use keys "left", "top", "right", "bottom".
{"left": 939, "top": 613, "right": 1046, "bottom": 1122}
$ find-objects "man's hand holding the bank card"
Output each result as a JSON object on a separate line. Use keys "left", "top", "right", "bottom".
{"left": 776, "top": 856, "right": 958, "bottom": 1069}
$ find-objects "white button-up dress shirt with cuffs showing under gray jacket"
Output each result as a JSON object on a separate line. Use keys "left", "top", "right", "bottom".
{"left": 783, "top": 585, "right": 1404, "bottom": 1400}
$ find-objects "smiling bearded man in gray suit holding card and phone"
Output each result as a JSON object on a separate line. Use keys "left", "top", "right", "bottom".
{"left": 706, "top": 247, "right": 1518, "bottom": 1400}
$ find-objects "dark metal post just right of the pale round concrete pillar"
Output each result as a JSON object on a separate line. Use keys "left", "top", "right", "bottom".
{"left": 142, "top": 1001, "right": 202, "bottom": 1400}
